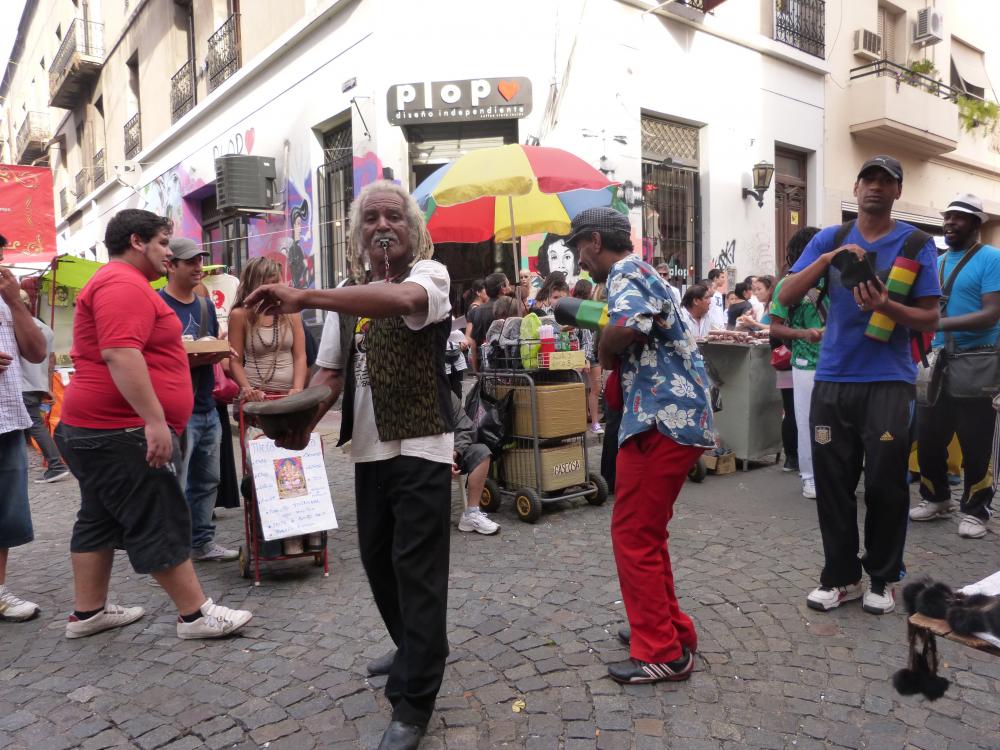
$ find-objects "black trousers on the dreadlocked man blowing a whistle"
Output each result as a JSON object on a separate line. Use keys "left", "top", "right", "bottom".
{"left": 354, "top": 456, "right": 451, "bottom": 726}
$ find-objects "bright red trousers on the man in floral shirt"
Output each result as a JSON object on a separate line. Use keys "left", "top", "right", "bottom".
{"left": 611, "top": 427, "right": 705, "bottom": 663}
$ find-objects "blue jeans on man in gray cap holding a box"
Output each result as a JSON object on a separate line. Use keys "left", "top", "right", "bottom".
{"left": 181, "top": 409, "right": 222, "bottom": 549}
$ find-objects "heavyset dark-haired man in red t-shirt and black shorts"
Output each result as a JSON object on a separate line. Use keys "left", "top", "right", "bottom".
{"left": 56, "top": 209, "right": 252, "bottom": 638}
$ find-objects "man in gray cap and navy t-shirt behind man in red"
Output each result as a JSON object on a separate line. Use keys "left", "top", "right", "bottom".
{"left": 160, "top": 237, "right": 239, "bottom": 562}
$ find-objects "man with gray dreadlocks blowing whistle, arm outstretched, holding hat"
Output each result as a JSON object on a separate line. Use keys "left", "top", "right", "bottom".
{"left": 246, "top": 181, "right": 454, "bottom": 750}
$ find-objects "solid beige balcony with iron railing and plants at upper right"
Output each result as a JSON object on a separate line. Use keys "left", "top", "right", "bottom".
{"left": 847, "top": 60, "right": 961, "bottom": 156}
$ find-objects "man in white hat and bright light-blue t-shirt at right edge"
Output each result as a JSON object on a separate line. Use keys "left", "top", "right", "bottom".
{"left": 910, "top": 193, "right": 1000, "bottom": 539}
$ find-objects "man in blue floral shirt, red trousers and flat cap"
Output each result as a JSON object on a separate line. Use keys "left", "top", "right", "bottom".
{"left": 566, "top": 208, "right": 715, "bottom": 683}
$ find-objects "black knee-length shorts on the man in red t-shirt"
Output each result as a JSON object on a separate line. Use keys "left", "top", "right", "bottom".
{"left": 55, "top": 422, "right": 191, "bottom": 573}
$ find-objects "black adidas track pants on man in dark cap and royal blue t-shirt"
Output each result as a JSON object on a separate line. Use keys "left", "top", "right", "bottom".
{"left": 809, "top": 381, "right": 914, "bottom": 586}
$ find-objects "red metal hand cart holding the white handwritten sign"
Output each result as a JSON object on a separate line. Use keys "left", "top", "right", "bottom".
{"left": 238, "top": 394, "right": 330, "bottom": 586}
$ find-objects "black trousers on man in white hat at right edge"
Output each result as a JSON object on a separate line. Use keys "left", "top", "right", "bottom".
{"left": 917, "top": 393, "right": 996, "bottom": 521}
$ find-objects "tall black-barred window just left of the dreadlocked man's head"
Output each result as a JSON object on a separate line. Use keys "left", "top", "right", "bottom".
{"left": 316, "top": 123, "right": 354, "bottom": 289}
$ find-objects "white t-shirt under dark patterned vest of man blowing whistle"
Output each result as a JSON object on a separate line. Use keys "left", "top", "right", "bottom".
{"left": 316, "top": 260, "right": 455, "bottom": 465}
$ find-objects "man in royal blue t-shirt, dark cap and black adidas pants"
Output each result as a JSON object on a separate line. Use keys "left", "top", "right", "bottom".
{"left": 778, "top": 156, "right": 941, "bottom": 614}
